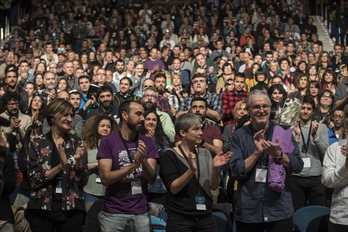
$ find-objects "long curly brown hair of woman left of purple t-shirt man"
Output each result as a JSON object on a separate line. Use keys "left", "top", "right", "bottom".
{"left": 82, "top": 113, "right": 120, "bottom": 149}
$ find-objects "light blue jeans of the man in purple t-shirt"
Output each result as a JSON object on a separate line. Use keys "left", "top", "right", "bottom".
{"left": 99, "top": 211, "right": 150, "bottom": 232}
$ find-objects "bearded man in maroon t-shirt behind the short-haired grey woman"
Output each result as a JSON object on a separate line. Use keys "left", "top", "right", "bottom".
{"left": 175, "top": 97, "right": 223, "bottom": 156}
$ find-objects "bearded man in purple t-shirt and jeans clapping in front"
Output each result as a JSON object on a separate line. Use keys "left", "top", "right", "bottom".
{"left": 97, "top": 101, "right": 159, "bottom": 232}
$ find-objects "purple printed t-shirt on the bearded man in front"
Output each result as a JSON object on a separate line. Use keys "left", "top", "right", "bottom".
{"left": 97, "top": 132, "right": 159, "bottom": 214}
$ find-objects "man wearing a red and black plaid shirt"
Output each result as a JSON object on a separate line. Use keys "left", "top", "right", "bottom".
{"left": 221, "top": 73, "right": 249, "bottom": 125}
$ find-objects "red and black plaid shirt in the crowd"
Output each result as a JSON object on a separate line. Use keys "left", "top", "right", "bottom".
{"left": 221, "top": 91, "right": 250, "bottom": 125}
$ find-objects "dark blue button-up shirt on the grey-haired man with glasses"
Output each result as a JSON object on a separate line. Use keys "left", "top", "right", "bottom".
{"left": 230, "top": 123, "right": 303, "bottom": 223}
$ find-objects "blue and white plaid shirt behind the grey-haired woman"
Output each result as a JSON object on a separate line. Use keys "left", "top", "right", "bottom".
{"left": 177, "top": 92, "right": 221, "bottom": 126}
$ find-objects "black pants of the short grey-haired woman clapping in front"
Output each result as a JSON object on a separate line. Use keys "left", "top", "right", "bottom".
{"left": 166, "top": 212, "right": 217, "bottom": 232}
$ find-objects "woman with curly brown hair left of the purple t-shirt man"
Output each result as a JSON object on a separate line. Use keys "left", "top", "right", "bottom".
{"left": 82, "top": 113, "right": 119, "bottom": 202}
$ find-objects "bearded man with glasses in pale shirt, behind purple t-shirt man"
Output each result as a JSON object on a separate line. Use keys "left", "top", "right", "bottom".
{"left": 141, "top": 87, "right": 175, "bottom": 142}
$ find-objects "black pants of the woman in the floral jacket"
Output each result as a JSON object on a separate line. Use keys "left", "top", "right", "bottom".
{"left": 26, "top": 210, "right": 85, "bottom": 232}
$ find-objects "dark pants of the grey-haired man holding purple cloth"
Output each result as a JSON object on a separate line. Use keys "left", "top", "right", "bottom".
{"left": 236, "top": 217, "right": 293, "bottom": 232}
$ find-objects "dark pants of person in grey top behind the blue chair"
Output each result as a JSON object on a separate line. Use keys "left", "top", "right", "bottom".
{"left": 290, "top": 176, "right": 326, "bottom": 211}
